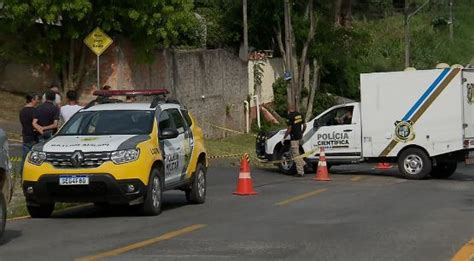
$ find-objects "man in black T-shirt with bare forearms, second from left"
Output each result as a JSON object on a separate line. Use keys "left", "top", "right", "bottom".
{"left": 33, "top": 90, "right": 59, "bottom": 142}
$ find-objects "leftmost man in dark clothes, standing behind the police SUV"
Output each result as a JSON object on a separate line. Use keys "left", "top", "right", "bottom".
{"left": 20, "top": 94, "right": 40, "bottom": 173}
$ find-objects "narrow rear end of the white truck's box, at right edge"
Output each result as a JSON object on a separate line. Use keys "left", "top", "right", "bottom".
{"left": 463, "top": 69, "right": 474, "bottom": 148}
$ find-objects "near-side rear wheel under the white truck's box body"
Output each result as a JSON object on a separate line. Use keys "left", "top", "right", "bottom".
{"left": 398, "top": 148, "right": 432, "bottom": 179}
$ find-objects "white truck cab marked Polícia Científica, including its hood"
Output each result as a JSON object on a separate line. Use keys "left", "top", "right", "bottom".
{"left": 257, "top": 102, "right": 362, "bottom": 173}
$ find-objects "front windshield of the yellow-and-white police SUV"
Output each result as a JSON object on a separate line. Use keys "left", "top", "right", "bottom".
{"left": 58, "top": 110, "right": 154, "bottom": 135}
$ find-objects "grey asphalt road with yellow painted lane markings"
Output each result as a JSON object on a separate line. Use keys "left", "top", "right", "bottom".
{"left": 0, "top": 146, "right": 474, "bottom": 260}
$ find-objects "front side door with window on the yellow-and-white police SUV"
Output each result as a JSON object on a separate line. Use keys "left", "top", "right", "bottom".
{"left": 158, "top": 109, "right": 183, "bottom": 185}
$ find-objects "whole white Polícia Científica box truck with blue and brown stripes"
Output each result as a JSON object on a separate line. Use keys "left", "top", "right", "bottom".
{"left": 256, "top": 68, "right": 474, "bottom": 179}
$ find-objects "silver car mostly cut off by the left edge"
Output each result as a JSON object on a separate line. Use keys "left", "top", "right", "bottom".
{"left": 0, "top": 129, "right": 13, "bottom": 237}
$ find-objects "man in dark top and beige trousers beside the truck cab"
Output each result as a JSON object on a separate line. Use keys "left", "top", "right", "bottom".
{"left": 282, "top": 106, "right": 306, "bottom": 177}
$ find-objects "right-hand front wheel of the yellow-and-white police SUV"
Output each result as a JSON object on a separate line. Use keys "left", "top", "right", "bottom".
{"left": 142, "top": 169, "right": 163, "bottom": 216}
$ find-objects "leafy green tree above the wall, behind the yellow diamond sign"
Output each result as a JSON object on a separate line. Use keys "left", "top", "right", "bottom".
{"left": 0, "top": 0, "right": 202, "bottom": 91}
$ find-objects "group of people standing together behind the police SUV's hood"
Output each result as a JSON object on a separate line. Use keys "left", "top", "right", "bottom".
{"left": 19, "top": 85, "right": 82, "bottom": 167}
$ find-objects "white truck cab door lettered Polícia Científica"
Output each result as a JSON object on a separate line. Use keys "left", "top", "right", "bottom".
{"left": 303, "top": 105, "right": 361, "bottom": 162}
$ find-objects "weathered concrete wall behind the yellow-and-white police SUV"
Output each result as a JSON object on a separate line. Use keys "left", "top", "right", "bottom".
{"left": 0, "top": 39, "right": 249, "bottom": 138}
